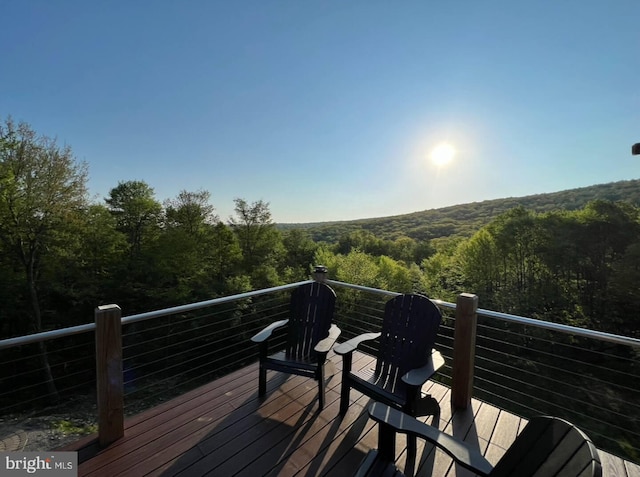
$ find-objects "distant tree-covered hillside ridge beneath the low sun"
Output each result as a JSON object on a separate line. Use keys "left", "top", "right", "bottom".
{"left": 278, "top": 179, "right": 640, "bottom": 243}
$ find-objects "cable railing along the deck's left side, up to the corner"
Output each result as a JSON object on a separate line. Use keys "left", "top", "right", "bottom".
{"left": 0, "top": 281, "right": 308, "bottom": 451}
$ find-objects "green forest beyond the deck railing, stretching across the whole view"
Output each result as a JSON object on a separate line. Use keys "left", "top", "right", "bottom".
{"left": 0, "top": 118, "right": 640, "bottom": 338}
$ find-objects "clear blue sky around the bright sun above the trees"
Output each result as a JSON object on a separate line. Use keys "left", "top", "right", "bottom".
{"left": 0, "top": 0, "right": 640, "bottom": 222}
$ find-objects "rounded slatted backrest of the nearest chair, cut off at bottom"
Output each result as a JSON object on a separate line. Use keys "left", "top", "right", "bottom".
{"left": 491, "top": 416, "right": 601, "bottom": 477}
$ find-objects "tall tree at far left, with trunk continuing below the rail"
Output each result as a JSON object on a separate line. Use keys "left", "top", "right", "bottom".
{"left": 0, "top": 118, "right": 87, "bottom": 399}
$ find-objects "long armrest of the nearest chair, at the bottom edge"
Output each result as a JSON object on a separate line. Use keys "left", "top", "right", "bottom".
{"left": 369, "top": 402, "right": 493, "bottom": 476}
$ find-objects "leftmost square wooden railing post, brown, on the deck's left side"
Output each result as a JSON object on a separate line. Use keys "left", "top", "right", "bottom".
{"left": 95, "top": 305, "right": 124, "bottom": 446}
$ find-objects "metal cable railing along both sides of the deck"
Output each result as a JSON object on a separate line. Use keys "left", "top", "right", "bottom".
{"left": 0, "top": 280, "right": 640, "bottom": 462}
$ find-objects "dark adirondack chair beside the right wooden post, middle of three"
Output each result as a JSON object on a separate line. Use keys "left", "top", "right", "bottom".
{"left": 334, "top": 294, "right": 444, "bottom": 416}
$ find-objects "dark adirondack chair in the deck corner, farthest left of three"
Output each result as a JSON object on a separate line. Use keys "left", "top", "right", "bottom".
{"left": 251, "top": 282, "right": 340, "bottom": 409}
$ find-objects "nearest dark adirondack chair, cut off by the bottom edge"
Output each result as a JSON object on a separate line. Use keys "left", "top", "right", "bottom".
{"left": 354, "top": 403, "right": 602, "bottom": 477}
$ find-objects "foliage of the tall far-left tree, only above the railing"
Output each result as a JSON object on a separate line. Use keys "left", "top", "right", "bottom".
{"left": 0, "top": 119, "right": 87, "bottom": 332}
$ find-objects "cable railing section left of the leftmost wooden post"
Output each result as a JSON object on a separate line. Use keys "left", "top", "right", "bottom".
{"left": 0, "top": 333, "right": 97, "bottom": 451}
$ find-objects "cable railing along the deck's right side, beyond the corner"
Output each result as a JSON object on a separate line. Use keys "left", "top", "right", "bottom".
{"left": 329, "top": 280, "right": 640, "bottom": 462}
